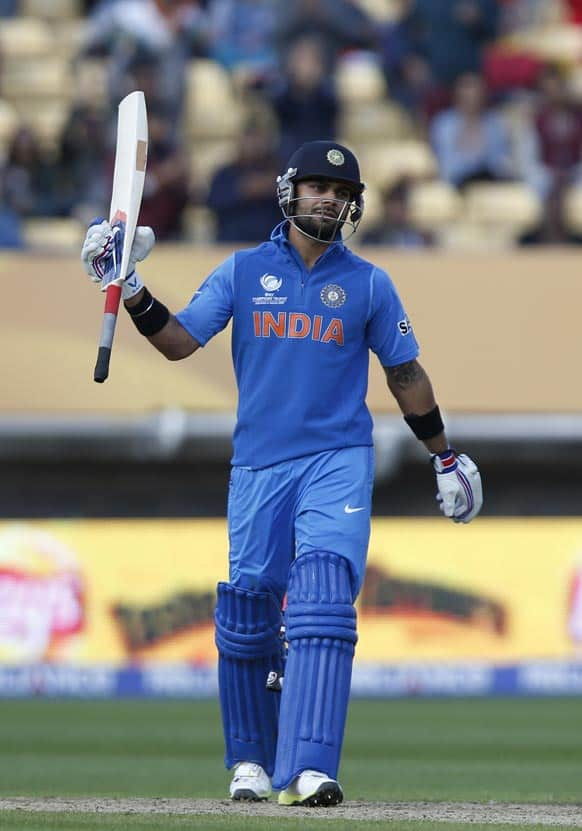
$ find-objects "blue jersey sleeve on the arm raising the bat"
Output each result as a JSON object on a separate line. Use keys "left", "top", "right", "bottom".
{"left": 176, "top": 254, "right": 235, "bottom": 346}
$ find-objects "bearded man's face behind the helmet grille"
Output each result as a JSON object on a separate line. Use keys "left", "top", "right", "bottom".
{"left": 293, "top": 179, "right": 354, "bottom": 242}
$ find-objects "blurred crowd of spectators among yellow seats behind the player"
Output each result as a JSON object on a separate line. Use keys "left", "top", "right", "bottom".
{"left": 0, "top": 0, "right": 582, "bottom": 248}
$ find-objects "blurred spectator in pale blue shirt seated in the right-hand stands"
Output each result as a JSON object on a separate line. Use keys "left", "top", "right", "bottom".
{"left": 431, "top": 74, "right": 511, "bottom": 187}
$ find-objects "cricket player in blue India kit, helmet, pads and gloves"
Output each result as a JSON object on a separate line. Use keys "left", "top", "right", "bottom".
{"left": 82, "top": 141, "right": 482, "bottom": 806}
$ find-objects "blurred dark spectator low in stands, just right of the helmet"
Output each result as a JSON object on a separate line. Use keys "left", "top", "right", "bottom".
{"left": 362, "top": 177, "right": 432, "bottom": 248}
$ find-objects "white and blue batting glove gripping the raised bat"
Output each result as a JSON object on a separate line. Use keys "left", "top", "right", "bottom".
{"left": 81, "top": 218, "right": 156, "bottom": 300}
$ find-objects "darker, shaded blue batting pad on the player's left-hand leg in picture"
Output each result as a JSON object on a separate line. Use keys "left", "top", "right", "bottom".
{"left": 214, "top": 583, "right": 283, "bottom": 776}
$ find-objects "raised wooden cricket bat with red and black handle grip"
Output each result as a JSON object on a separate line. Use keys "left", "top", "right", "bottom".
{"left": 93, "top": 90, "right": 148, "bottom": 384}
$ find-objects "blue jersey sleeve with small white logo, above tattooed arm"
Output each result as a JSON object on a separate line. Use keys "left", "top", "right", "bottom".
{"left": 366, "top": 268, "right": 419, "bottom": 366}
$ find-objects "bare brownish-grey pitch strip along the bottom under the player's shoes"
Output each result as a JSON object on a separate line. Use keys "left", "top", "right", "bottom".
{"left": 0, "top": 796, "right": 582, "bottom": 828}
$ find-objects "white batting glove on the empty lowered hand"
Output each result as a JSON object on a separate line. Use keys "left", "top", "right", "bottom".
{"left": 431, "top": 450, "right": 483, "bottom": 523}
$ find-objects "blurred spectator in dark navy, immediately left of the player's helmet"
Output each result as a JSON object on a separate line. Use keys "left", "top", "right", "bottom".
{"left": 207, "top": 121, "right": 282, "bottom": 242}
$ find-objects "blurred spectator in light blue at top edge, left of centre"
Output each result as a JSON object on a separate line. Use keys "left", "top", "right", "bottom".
{"left": 208, "top": 0, "right": 278, "bottom": 86}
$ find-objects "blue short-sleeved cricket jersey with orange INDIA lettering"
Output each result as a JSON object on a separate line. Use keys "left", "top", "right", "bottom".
{"left": 176, "top": 222, "right": 418, "bottom": 468}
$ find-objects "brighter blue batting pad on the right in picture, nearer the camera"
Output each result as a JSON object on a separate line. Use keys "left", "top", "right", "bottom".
{"left": 273, "top": 551, "right": 358, "bottom": 790}
